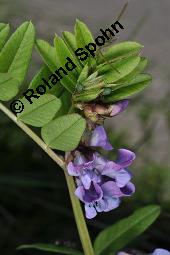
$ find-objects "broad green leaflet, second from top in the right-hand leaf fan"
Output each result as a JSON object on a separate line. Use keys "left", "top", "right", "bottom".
{"left": 99, "top": 56, "right": 140, "bottom": 83}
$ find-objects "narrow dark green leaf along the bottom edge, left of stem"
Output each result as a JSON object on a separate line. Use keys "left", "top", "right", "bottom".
{"left": 18, "top": 244, "right": 83, "bottom": 255}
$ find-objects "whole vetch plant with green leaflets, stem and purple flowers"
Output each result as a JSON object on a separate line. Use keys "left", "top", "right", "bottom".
{"left": 0, "top": 3, "right": 163, "bottom": 255}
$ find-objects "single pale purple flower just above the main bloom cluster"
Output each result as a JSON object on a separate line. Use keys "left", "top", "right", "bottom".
{"left": 90, "top": 126, "right": 113, "bottom": 151}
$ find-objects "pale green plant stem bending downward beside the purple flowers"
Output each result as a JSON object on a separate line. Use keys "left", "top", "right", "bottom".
{"left": 0, "top": 103, "right": 94, "bottom": 255}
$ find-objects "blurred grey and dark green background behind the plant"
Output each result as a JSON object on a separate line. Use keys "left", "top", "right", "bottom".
{"left": 0, "top": 0, "right": 170, "bottom": 255}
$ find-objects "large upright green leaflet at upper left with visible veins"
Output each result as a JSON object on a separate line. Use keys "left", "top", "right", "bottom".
{"left": 0, "top": 22, "right": 35, "bottom": 84}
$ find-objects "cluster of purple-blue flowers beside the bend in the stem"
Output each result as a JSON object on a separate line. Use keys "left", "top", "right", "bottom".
{"left": 67, "top": 98, "right": 135, "bottom": 219}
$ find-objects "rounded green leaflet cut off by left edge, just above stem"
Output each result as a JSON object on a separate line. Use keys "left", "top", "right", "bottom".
{"left": 0, "top": 73, "right": 19, "bottom": 101}
